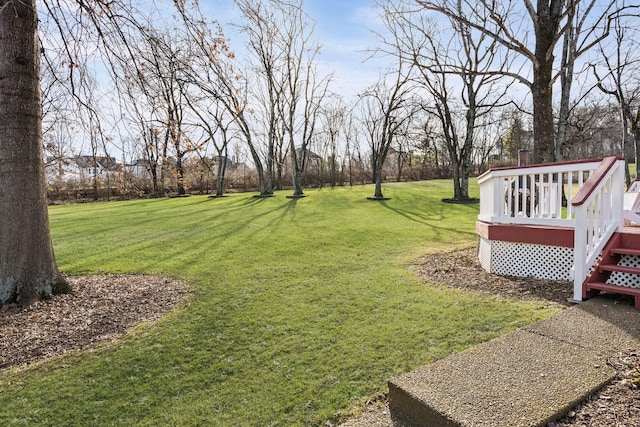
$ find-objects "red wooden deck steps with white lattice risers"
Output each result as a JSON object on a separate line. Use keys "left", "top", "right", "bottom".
{"left": 582, "top": 233, "right": 640, "bottom": 310}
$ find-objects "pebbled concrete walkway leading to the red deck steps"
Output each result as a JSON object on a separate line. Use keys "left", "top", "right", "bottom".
{"left": 344, "top": 296, "right": 640, "bottom": 427}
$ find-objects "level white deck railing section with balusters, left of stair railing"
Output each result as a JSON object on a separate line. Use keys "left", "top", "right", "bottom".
{"left": 478, "top": 160, "right": 600, "bottom": 227}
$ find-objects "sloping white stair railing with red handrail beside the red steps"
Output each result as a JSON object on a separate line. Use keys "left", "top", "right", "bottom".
{"left": 571, "top": 157, "right": 624, "bottom": 301}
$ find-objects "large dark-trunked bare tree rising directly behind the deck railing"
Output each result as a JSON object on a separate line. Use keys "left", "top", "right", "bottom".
{"left": 417, "top": 0, "right": 640, "bottom": 163}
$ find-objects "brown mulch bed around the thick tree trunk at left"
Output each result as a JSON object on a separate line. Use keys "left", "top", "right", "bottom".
{"left": 0, "top": 275, "right": 187, "bottom": 369}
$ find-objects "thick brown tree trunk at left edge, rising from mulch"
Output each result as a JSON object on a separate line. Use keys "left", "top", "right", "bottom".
{"left": 0, "top": 0, "right": 68, "bottom": 305}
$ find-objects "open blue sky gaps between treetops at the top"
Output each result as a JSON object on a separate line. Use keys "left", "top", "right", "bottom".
{"left": 201, "top": 0, "right": 383, "bottom": 97}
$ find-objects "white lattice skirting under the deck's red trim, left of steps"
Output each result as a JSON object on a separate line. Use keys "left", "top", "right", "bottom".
{"left": 478, "top": 237, "right": 573, "bottom": 280}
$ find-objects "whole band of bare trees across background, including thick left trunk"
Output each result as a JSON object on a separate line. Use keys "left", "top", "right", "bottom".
{"left": 0, "top": 0, "right": 640, "bottom": 303}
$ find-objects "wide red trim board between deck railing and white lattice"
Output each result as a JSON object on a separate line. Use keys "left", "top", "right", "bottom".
{"left": 476, "top": 221, "right": 573, "bottom": 248}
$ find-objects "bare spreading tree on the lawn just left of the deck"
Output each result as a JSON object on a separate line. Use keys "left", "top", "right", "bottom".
{"left": 384, "top": 3, "right": 509, "bottom": 200}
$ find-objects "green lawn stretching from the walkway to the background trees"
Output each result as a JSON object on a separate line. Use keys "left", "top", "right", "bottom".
{"left": 0, "top": 181, "right": 553, "bottom": 426}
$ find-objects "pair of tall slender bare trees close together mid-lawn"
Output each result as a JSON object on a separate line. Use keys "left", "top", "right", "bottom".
{"left": 236, "top": 0, "right": 327, "bottom": 197}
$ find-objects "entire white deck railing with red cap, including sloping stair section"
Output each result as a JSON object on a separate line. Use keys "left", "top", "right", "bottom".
{"left": 478, "top": 157, "right": 624, "bottom": 301}
